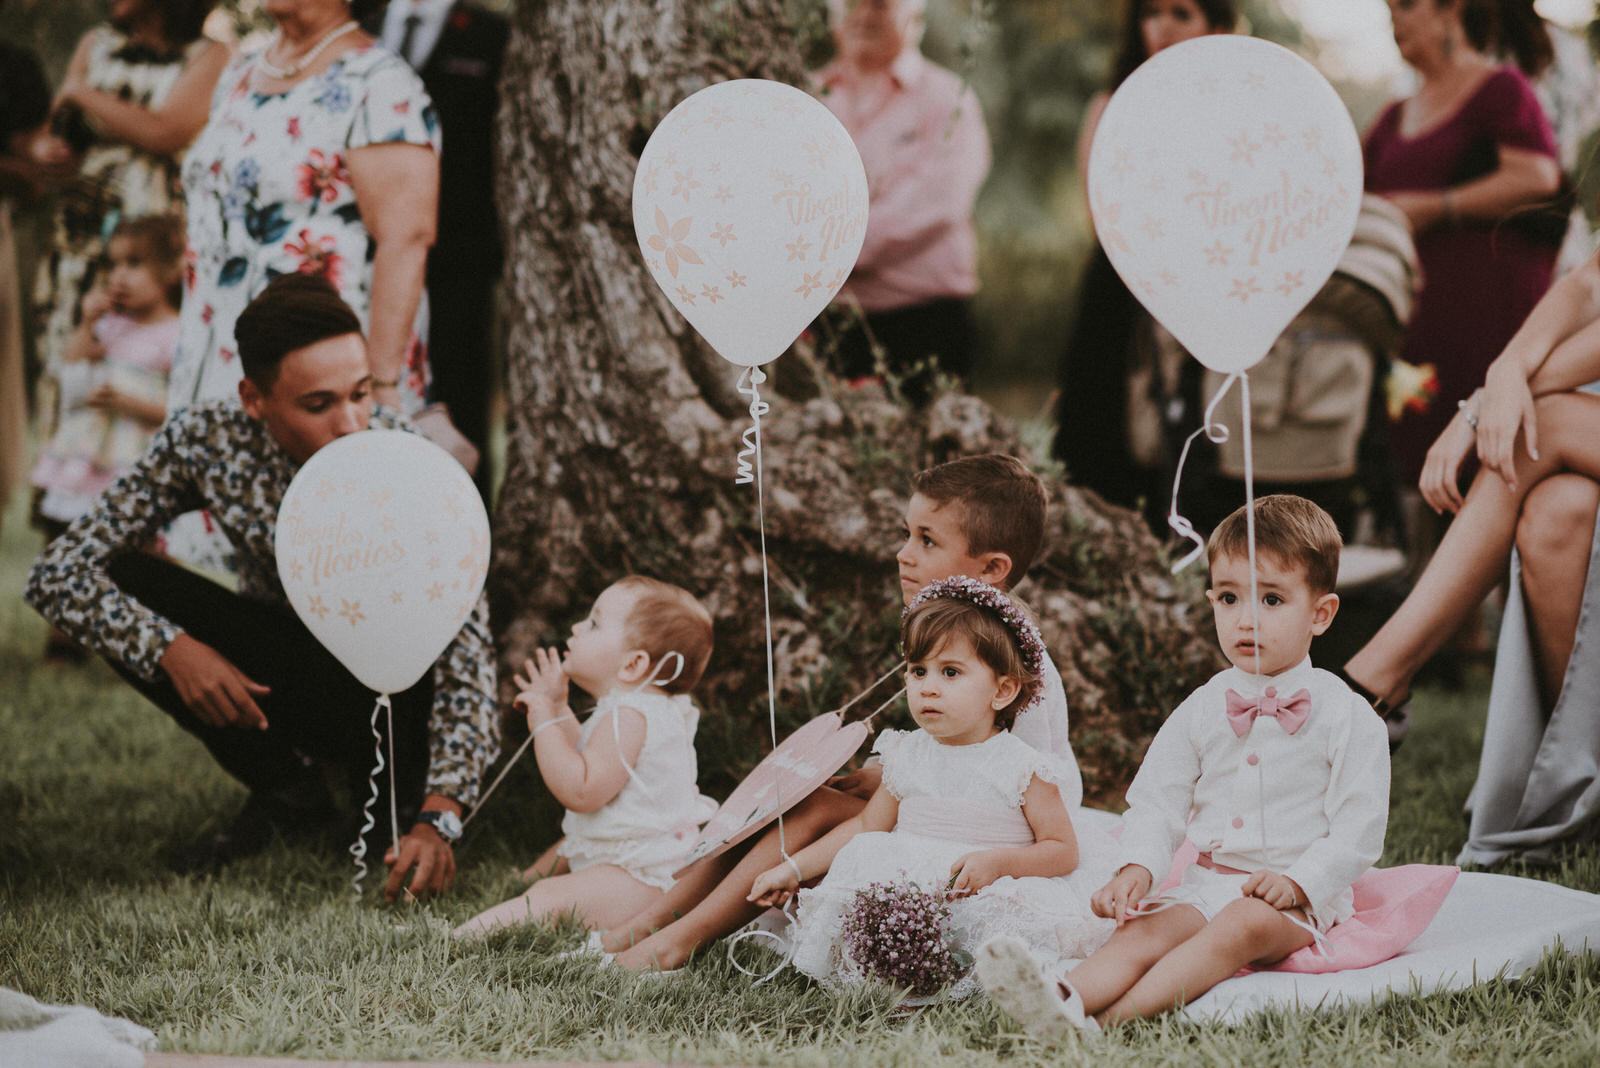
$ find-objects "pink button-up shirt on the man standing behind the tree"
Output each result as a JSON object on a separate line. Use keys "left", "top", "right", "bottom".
{"left": 816, "top": 48, "right": 989, "bottom": 312}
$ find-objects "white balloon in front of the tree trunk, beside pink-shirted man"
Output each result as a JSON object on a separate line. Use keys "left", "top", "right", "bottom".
{"left": 634, "top": 78, "right": 867, "bottom": 368}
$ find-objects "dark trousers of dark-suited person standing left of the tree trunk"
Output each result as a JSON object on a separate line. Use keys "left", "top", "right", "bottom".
{"left": 427, "top": 270, "right": 494, "bottom": 502}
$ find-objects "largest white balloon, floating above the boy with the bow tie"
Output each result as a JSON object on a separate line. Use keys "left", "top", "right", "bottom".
{"left": 1088, "top": 34, "right": 1362, "bottom": 373}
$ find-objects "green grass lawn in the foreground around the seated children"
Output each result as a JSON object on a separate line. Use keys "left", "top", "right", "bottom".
{"left": 0, "top": 495, "right": 1600, "bottom": 1068}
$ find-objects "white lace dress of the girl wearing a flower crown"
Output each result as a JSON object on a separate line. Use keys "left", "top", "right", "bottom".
{"left": 792, "top": 731, "right": 1117, "bottom": 998}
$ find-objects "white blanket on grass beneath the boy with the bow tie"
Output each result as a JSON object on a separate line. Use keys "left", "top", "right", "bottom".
{"left": 1186, "top": 871, "right": 1600, "bottom": 1023}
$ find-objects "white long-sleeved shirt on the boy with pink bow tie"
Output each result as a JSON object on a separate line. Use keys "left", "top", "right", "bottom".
{"left": 1118, "top": 657, "right": 1389, "bottom": 913}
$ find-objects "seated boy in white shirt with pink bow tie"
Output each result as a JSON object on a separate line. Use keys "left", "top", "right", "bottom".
{"left": 978, "top": 494, "right": 1389, "bottom": 1041}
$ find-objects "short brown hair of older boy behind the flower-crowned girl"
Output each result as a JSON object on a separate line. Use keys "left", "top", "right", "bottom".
{"left": 910, "top": 452, "right": 1046, "bottom": 588}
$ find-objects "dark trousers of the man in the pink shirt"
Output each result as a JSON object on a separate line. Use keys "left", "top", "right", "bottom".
{"left": 830, "top": 297, "right": 976, "bottom": 404}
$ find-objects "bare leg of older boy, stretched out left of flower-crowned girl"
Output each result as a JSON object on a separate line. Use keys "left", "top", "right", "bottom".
{"left": 616, "top": 787, "right": 866, "bottom": 970}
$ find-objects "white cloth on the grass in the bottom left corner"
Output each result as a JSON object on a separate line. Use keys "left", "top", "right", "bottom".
{"left": 0, "top": 986, "right": 155, "bottom": 1068}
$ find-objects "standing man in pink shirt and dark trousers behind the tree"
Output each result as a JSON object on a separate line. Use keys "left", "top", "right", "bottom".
{"left": 816, "top": 0, "right": 989, "bottom": 401}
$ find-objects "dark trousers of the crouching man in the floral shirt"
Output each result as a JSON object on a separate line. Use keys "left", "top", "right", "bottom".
{"left": 110, "top": 553, "right": 434, "bottom": 830}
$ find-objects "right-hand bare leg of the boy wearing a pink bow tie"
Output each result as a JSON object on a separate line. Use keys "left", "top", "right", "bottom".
{"left": 1100, "top": 897, "right": 1312, "bottom": 1023}
